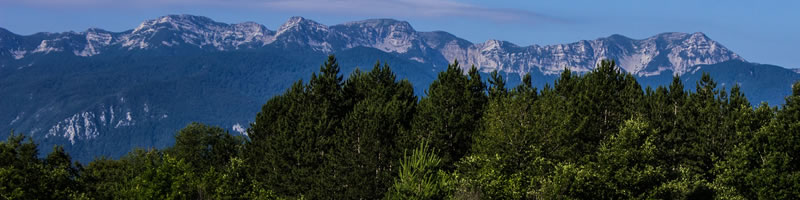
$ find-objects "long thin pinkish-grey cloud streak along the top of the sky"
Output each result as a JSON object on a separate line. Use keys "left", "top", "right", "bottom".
{"left": 0, "top": 0, "right": 567, "bottom": 23}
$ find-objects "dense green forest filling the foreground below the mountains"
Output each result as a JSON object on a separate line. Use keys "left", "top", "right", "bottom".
{"left": 0, "top": 56, "right": 800, "bottom": 199}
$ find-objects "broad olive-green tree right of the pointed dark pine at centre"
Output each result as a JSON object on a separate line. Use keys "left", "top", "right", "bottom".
{"left": 468, "top": 70, "right": 541, "bottom": 199}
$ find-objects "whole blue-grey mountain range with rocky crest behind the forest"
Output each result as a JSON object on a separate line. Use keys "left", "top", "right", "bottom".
{"left": 0, "top": 15, "right": 800, "bottom": 161}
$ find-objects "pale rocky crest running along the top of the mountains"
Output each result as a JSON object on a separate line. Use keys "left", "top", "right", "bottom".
{"left": 0, "top": 14, "right": 746, "bottom": 76}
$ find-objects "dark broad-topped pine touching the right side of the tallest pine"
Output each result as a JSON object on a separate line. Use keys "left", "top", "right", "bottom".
{"left": 328, "top": 63, "right": 417, "bottom": 199}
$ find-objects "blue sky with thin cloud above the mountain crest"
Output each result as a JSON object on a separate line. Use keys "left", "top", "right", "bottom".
{"left": 0, "top": 0, "right": 800, "bottom": 68}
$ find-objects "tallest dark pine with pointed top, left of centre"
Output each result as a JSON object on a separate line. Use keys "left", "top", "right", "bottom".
{"left": 246, "top": 55, "right": 347, "bottom": 198}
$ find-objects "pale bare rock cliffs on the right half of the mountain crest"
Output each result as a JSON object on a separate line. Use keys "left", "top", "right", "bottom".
{"left": 432, "top": 33, "right": 744, "bottom": 76}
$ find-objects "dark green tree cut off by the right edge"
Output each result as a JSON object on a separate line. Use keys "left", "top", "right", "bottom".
{"left": 716, "top": 82, "right": 800, "bottom": 199}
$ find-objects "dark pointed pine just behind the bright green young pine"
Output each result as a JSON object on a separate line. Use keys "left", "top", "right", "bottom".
{"left": 412, "top": 61, "right": 487, "bottom": 167}
